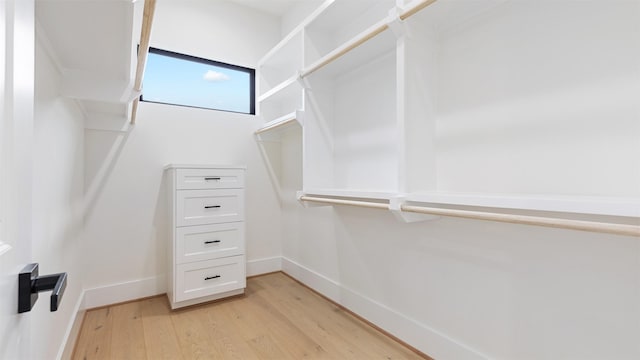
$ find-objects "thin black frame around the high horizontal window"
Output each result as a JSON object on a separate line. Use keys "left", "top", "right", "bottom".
{"left": 140, "top": 47, "right": 256, "bottom": 115}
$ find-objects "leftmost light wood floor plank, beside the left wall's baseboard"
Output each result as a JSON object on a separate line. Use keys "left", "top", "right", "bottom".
{"left": 73, "top": 307, "right": 113, "bottom": 360}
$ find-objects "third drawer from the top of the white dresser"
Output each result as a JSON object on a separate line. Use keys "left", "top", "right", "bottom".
{"left": 175, "top": 223, "right": 244, "bottom": 264}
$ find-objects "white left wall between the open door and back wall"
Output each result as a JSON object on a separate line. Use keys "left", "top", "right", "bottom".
{"left": 30, "top": 38, "right": 84, "bottom": 359}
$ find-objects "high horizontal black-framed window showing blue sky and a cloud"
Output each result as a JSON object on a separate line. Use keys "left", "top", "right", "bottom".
{"left": 140, "top": 48, "right": 256, "bottom": 114}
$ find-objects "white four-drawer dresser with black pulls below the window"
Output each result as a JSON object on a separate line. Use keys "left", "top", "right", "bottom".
{"left": 165, "top": 165, "right": 246, "bottom": 309}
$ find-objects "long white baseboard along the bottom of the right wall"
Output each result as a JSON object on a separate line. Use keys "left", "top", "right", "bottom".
{"left": 282, "top": 257, "right": 489, "bottom": 359}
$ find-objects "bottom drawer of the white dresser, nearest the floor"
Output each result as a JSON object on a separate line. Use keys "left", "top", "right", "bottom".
{"left": 175, "top": 255, "right": 247, "bottom": 302}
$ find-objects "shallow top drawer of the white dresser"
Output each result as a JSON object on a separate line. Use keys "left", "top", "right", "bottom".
{"left": 176, "top": 169, "right": 244, "bottom": 190}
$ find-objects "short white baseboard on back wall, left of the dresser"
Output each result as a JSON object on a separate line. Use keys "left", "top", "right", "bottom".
{"left": 84, "top": 275, "right": 167, "bottom": 309}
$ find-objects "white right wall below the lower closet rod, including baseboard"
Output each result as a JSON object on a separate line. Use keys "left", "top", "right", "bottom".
{"left": 283, "top": 204, "right": 640, "bottom": 359}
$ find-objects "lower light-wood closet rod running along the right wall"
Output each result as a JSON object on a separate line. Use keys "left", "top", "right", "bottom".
{"left": 300, "top": 196, "right": 640, "bottom": 237}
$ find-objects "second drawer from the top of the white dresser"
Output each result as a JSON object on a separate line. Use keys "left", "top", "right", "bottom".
{"left": 176, "top": 189, "right": 244, "bottom": 226}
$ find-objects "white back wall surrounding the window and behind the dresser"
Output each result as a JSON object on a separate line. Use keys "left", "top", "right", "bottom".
{"left": 85, "top": 1, "right": 281, "bottom": 306}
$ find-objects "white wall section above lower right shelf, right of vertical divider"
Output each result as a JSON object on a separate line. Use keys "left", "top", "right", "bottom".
{"left": 436, "top": 1, "right": 640, "bottom": 197}
